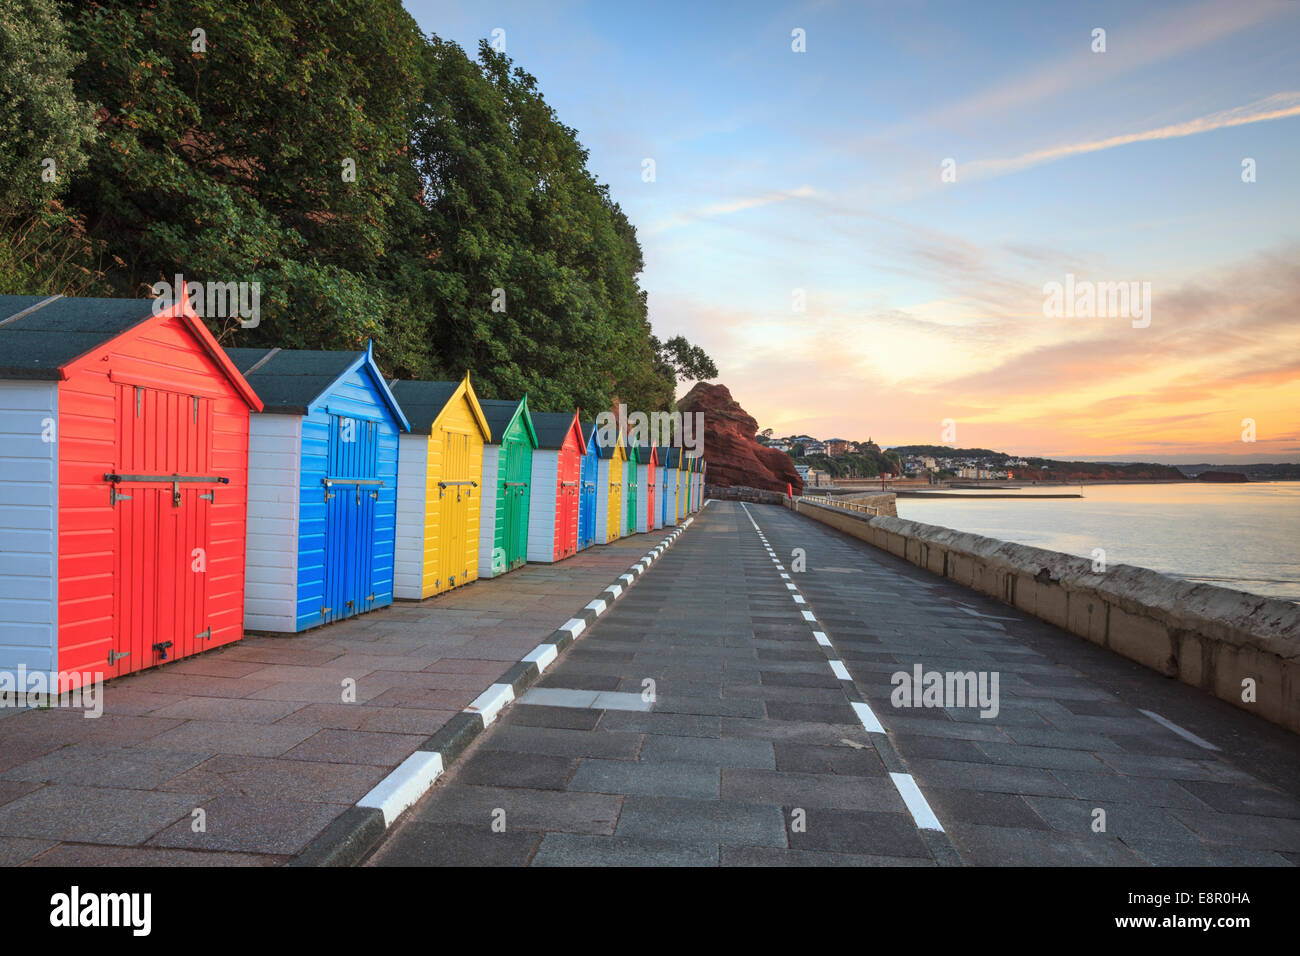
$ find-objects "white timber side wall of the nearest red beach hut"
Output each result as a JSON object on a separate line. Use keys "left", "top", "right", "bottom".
{"left": 0, "top": 381, "right": 59, "bottom": 671}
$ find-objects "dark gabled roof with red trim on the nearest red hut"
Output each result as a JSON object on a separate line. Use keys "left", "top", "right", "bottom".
{"left": 0, "top": 291, "right": 261, "bottom": 411}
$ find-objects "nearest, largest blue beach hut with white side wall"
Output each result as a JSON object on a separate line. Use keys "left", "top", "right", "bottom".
{"left": 218, "top": 345, "right": 411, "bottom": 632}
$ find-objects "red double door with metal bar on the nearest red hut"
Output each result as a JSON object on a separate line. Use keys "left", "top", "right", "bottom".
{"left": 110, "top": 384, "right": 214, "bottom": 676}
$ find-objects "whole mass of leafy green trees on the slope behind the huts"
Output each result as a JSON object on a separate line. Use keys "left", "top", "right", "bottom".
{"left": 0, "top": 0, "right": 716, "bottom": 411}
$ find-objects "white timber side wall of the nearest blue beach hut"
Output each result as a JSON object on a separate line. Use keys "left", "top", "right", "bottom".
{"left": 244, "top": 412, "right": 303, "bottom": 633}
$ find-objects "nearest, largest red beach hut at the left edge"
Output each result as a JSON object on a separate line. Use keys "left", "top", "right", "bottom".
{"left": 0, "top": 291, "right": 263, "bottom": 687}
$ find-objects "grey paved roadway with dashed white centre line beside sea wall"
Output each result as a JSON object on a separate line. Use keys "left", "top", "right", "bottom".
{"left": 368, "top": 501, "right": 1300, "bottom": 866}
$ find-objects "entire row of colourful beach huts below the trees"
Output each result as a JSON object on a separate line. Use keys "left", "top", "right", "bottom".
{"left": 0, "top": 295, "right": 703, "bottom": 685}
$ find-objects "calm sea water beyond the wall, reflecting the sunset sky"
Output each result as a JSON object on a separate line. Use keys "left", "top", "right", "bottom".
{"left": 898, "top": 481, "right": 1300, "bottom": 601}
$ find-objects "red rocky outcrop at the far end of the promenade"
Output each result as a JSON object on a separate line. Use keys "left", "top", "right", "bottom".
{"left": 677, "top": 382, "right": 803, "bottom": 494}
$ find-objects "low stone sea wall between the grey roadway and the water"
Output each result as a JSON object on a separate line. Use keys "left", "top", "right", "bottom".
{"left": 794, "top": 499, "right": 1300, "bottom": 734}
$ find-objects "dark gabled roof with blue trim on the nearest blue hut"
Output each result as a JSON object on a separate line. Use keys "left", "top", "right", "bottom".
{"left": 226, "top": 343, "right": 411, "bottom": 432}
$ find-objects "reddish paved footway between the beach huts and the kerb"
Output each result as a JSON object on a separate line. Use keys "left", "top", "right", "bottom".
{"left": 0, "top": 532, "right": 664, "bottom": 866}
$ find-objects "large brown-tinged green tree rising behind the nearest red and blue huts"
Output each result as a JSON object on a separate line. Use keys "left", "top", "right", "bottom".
{"left": 65, "top": 0, "right": 421, "bottom": 347}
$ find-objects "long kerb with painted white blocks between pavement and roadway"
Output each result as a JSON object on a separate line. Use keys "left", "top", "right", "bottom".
{"left": 286, "top": 515, "right": 709, "bottom": 866}
